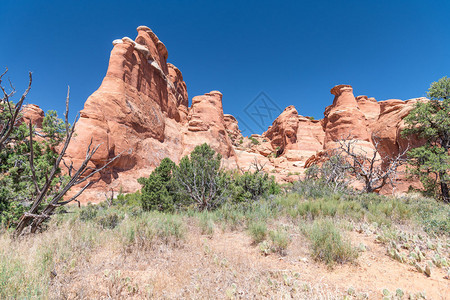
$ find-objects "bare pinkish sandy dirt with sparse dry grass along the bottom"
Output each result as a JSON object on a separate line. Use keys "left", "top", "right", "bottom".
{"left": 52, "top": 221, "right": 450, "bottom": 299}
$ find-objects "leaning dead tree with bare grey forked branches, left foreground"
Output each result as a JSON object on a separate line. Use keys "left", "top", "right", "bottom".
{"left": 14, "top": 89, "right": 120, "bottom": 236}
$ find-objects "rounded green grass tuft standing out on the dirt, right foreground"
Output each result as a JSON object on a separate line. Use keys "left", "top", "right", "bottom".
{"left": 302, "top": 219, "right": 358, "bottom": 267}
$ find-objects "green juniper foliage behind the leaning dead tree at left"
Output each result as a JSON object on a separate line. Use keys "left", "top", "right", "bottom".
{"left": 0, "top": 104, "right": 65, "bottom": 227}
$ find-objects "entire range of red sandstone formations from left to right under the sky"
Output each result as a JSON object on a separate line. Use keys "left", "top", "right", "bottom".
{"left": 28, "top": 26, "right": 426, "bottom": 202}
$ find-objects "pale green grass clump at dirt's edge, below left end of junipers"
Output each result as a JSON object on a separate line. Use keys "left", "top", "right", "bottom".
{"left": 117, "top": 212, "right": 185, "bottom": 249}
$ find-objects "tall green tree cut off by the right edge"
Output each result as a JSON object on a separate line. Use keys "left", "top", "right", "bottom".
{"left": 403, "top": 77, "right": 450, "bottom": 203}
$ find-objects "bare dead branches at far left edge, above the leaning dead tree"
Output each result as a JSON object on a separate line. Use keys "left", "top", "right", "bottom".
{"left": 0, "top": 68, "right": 33, "bottom": 151}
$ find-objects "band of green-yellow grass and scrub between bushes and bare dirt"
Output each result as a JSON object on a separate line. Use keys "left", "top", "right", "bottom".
{"left": 0, "top": 173, "right": 450, "bottom": 298}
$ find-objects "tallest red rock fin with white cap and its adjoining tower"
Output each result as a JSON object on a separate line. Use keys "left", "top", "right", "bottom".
{"left": 66, "top": 26, "right": 235, "bottom": 201}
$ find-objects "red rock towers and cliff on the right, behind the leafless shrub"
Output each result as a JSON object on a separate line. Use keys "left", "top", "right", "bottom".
{"left": 256, "top": 85, "right": 427, "bottom": 193}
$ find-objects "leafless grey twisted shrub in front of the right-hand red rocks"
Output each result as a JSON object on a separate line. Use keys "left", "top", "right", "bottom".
{"left": 338, "top": 135, "right": 409, "bottom": 193}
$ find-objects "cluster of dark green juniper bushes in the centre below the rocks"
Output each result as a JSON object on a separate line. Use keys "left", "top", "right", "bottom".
{"left": 135, "top": 144, "right": 281, "bottom": 212}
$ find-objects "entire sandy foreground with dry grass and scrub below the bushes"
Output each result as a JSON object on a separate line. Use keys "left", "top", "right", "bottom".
{"left": 0, "top": 195, "right": 450, "bottom": 299}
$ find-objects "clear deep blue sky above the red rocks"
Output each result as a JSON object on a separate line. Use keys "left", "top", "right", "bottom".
{"left": 0, "top": 0, "right": 450, "bottom": 133}
